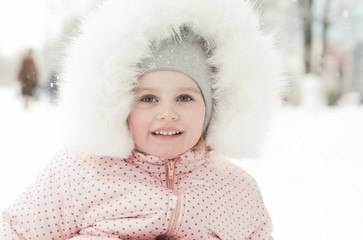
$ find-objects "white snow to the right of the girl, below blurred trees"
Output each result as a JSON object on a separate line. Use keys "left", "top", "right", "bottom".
{"left": 232, "top": 107, "right": 363, "bottom": 240}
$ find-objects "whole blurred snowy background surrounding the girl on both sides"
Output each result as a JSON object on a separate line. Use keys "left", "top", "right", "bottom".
{"left": 0, "top": 0, "right": 363, "bottom": 240}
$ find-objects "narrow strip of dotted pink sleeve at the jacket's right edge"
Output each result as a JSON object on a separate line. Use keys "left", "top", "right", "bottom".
{"left": 247, "top": 180, "right": 273, "bottom": 240}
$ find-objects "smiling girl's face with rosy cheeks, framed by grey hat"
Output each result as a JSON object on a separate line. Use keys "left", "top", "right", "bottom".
{"left": 128, "top": 71, "right": 205, "bottom": 159}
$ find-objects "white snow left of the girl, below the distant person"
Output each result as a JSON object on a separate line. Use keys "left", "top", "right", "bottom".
{"left": 0, "top": 86, "right": 62, "bottom": 208}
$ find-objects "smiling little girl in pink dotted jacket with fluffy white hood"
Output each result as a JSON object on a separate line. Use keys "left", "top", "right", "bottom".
{"left": 0, "top": 0, "right": 282, "bottom": 240}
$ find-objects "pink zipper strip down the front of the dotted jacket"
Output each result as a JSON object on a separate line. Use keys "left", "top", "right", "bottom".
{"left": 165, "top": 159, "right": 180, "bottom": 237}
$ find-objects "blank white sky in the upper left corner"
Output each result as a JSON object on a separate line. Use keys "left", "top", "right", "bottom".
{"left": 0, "top": 0, "right": 95, "bottom": 56}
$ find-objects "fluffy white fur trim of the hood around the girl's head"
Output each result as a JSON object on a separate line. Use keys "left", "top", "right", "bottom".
{"left": 61, "top": 0, "right": 288, "bottom": 157}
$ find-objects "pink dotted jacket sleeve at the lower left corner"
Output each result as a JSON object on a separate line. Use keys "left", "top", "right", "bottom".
{"left": 0, "top": 151, "right": 77, "bottom": 240}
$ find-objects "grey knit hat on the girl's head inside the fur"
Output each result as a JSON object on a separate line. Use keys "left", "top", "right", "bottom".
{"left": 139, "top": 33, "right": 212, "bottom": 133}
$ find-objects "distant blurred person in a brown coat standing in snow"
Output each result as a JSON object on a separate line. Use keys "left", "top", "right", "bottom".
{"left": 18, "top": 49, "right": 38, "bottom": 108}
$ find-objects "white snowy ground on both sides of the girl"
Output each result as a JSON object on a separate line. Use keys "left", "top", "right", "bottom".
{"left": 0, "top": 87, "right": 363, "bottom": 240}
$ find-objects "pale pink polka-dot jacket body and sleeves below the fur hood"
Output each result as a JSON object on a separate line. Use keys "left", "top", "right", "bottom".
{"left": 0, "top": 150, "right": 272, "bottom": 240}
